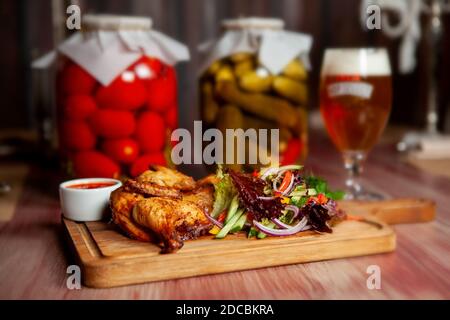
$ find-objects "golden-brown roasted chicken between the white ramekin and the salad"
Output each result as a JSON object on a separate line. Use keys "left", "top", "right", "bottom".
{"left": 111, "top": 166, "right": 214, "bottom": 253}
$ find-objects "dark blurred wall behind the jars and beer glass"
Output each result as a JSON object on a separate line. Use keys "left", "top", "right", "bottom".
{"left": 0, "top": 0, "right": 450, "bottom": 135}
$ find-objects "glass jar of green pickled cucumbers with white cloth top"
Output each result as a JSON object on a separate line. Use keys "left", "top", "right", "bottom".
{"left": 199, "top": 18, "right": 312, "bottom": 171}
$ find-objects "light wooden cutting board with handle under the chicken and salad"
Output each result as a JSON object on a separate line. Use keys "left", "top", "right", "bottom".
{"left": 62, "top": 201, "right": 434, "bottom": 288}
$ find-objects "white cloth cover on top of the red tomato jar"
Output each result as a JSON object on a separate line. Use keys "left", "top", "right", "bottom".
{"left": 33, "top": 15, "right": 190, "bottom": 86}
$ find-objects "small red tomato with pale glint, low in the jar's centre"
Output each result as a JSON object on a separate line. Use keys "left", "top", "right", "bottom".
{"left": 102, "top": 138, "right": 139, "bottom": 164}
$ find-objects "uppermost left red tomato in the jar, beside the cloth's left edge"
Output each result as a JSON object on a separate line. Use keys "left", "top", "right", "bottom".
{"left": 61, "top": 62, "right": 97, "bottom": 95}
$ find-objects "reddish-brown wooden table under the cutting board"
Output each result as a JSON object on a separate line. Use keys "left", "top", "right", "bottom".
{"left": 0, "top": 136, "right": 450, "bottom": 299}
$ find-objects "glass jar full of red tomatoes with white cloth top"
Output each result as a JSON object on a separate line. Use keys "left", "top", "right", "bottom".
{"left": 57, "top": 16, "right": 188, "bottom": 178}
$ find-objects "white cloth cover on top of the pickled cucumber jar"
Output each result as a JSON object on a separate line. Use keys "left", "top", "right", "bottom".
{"left": 199, "top": 18, "right": 312, "bottom": 75}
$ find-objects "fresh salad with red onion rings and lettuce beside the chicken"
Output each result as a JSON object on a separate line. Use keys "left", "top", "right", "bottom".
{"left": 207, "top": 165, "right": 345, "bottom": 239}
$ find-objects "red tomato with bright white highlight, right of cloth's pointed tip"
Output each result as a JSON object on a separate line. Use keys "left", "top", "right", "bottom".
{"left": 95, "top": 71, "right": 147, "bottom": 110}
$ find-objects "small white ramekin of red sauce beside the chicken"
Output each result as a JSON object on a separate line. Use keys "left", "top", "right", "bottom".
{"left": 59, "top": 178, "right": 122, "bottom": 221}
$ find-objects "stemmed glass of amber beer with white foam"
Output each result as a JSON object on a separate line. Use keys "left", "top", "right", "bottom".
{"left": 320, "top": 48, "right": 392, "bottom": 200}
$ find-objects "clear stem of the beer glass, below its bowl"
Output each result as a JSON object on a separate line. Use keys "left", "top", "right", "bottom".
{"left": 342, "top": 151, "right": 366, "bottom": 199}
